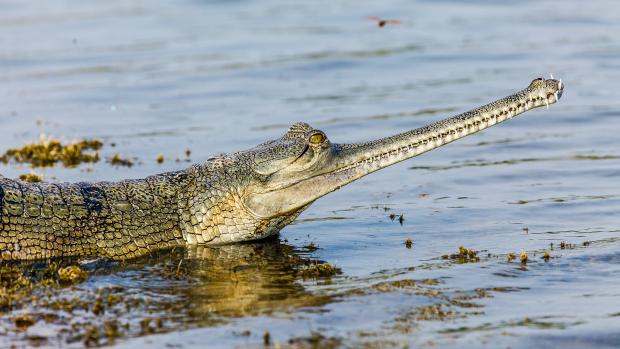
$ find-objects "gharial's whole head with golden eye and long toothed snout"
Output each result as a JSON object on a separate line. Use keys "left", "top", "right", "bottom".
{"left": 191, "top": 78, "right": 564, "bottom": 242}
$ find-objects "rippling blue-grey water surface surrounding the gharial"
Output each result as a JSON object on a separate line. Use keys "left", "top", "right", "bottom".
{"left": 0, "top": 0, "right": 620, "bottom": 348}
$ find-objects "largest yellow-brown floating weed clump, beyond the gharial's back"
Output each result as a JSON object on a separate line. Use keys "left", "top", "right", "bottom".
{"left": 0, "top": 135, "right": 103, "bottom": 167}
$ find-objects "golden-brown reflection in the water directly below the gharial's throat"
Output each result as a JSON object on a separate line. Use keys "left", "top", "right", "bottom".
{"left": 179, "top": 241, "right": 331, "bottom": 317}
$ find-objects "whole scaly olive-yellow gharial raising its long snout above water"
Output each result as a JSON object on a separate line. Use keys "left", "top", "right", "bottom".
{"left": 0, "top": 78, "right": 564, "bottom": 260}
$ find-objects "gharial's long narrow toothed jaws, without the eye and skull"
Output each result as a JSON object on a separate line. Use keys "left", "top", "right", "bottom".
{"left": 248, "top": 78, "right": 564, "bottom": 216}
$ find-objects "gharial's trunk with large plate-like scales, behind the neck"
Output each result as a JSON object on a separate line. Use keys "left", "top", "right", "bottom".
{"left": 0, "top": 172, "right": 187, "bottom": 260}
